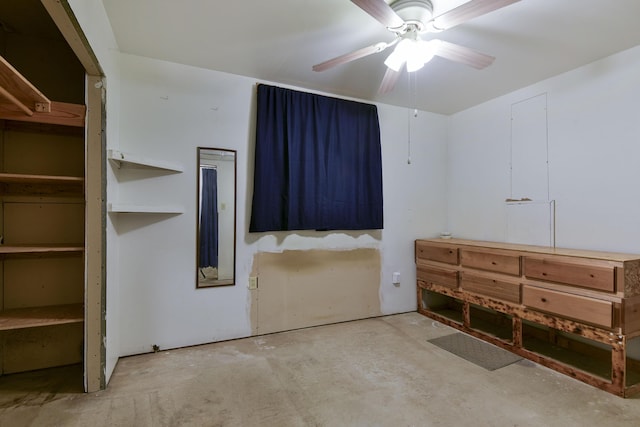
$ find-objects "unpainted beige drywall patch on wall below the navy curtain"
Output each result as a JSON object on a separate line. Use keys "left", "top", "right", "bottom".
{"left": 251, "top": 248, "right": 382, "bottom": 335}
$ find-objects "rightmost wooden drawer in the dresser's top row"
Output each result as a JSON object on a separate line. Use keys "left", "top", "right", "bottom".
{"left": 524, "top": 257, "right": 615, "bottom": 292}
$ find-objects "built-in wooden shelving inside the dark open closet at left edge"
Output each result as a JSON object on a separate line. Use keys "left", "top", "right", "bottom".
{"left": 0, "top": 50, "right": 86, "bottom": 375}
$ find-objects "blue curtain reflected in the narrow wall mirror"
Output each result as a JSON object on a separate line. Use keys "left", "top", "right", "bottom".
{"left": 199, "top": 168, "right": 218, "bottom": 268}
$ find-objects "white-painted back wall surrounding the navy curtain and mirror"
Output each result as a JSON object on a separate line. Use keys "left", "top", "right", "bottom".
{"left": 110, "top": 54, "right": 446, "bottom": 355}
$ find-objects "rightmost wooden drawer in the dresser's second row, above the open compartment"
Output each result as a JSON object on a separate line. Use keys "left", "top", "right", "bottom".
{"left": 522, "top": 285, "right": 613, "bottom": 328}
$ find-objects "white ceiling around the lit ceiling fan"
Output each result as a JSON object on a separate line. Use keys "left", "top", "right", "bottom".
{"left": 103, "top": 0, "right": 640, "bottom": 114}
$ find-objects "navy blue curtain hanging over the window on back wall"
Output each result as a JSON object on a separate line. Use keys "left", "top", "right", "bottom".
{"left": 249, "top": 84, "right": 383, "bottom": 232}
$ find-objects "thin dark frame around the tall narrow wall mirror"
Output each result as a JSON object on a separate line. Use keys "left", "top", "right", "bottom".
{"left": 195, "top": 147, "right": 238, "bottom": 289}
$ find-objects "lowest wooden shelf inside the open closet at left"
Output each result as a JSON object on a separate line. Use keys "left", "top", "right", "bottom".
{"left": 0, "top": 304, "right": 84, "bottom": 331}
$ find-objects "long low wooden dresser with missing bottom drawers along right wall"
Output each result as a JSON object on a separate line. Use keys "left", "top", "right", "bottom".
{"left": 415, "top": 239, "right": 640, "bottom": 397}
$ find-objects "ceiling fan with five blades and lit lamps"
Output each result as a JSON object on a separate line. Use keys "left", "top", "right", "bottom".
{"left": 313, "top": 0, "right": 520, "bottom": 93}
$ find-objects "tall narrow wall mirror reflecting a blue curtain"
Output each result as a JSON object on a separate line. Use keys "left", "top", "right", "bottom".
{"left": 196, "top": 147, "right": 236, "bottom": 288}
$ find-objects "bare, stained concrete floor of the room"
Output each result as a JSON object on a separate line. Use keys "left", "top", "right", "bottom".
{"left": 0, "top": 313, "right": 640, "bottom": 427}
